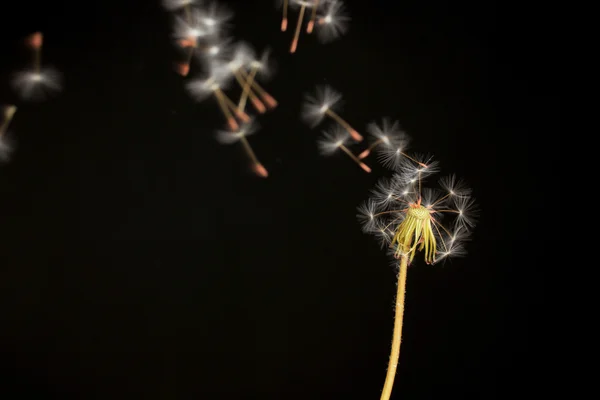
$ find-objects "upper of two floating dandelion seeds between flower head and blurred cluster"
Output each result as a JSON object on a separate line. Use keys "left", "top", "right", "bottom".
{"left": 302, "top": 86, "right": 363, "bottom": 142}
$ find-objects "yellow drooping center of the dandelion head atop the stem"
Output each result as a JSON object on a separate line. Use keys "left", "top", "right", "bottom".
{"left": 392, "top": 202, "right": 436, "bottom": 264}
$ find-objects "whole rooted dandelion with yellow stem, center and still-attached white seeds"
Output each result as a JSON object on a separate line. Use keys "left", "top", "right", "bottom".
{"left": 358, "top": 155, "right": 476, "bottom": 400}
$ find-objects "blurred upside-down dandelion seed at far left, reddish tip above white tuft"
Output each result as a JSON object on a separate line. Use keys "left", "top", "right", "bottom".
{"left": 12, "top": 32, "right": 62, "bottom": 100}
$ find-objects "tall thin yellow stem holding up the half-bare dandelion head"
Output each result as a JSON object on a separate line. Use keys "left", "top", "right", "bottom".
{"left": 381, "top": 255, "right": 408, "bottom": 400}
